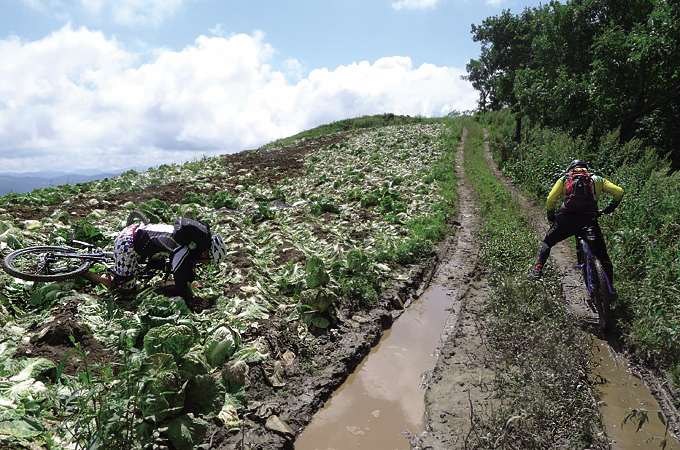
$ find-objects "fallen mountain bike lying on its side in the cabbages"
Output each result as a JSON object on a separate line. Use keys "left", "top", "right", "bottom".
{"left": 2, "top": 211, "right": 153, "bottom": 282}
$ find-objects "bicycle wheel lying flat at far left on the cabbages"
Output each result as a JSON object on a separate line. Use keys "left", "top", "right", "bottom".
{"left": 2, "top": 246, "right": 90, "bottom": 282}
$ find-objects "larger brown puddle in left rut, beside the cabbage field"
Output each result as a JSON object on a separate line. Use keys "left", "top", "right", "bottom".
{"left": 295, "top": 286, "right": 453, "bottom": 450}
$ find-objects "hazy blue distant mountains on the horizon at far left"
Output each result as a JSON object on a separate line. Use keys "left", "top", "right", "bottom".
{"left": 0, "top": 170, "right": 132, "bottom": 195}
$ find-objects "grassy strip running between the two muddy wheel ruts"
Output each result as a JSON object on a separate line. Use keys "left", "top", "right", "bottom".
{"left": 464, "top": 120, "right": 606, "bottom": 449}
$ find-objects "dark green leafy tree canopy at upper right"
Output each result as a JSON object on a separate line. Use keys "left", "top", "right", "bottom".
{"left": 466, "top": 0, "right": 680, "bottom": 165}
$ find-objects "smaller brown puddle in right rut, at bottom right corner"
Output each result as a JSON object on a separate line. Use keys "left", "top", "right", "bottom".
{"left": 593, "top": 338, "right": 680, "bottom": 450}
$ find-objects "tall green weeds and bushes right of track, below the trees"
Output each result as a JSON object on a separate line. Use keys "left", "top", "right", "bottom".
{"left": 488, "top": 107, "right": 680, "bottom": 402}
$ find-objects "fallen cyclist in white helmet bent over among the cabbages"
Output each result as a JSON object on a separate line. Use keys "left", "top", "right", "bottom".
{"left": 83, "top": 217, "right": 227, "bottom": 309}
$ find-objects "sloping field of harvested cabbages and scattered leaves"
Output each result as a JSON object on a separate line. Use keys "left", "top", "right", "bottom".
{"left": 0, "top": 115, "right": 460, "bottom": 450}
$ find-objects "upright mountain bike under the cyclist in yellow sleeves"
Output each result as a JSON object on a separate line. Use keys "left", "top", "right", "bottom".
{"left": 573, "top": 227, "right": 614, "bottom": 333}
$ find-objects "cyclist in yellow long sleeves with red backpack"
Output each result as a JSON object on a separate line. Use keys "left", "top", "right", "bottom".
{"left": 532, "top": 159, "right": 625, "bottom": 286}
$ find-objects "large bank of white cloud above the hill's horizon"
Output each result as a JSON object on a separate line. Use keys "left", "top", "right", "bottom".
{"left": 0, "top": 26, "right": 477, "bottom": 171}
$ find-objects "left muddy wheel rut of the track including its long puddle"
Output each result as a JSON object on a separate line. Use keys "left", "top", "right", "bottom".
{"left": 295, "top": 128, "right": 493, "bottom": 450}
